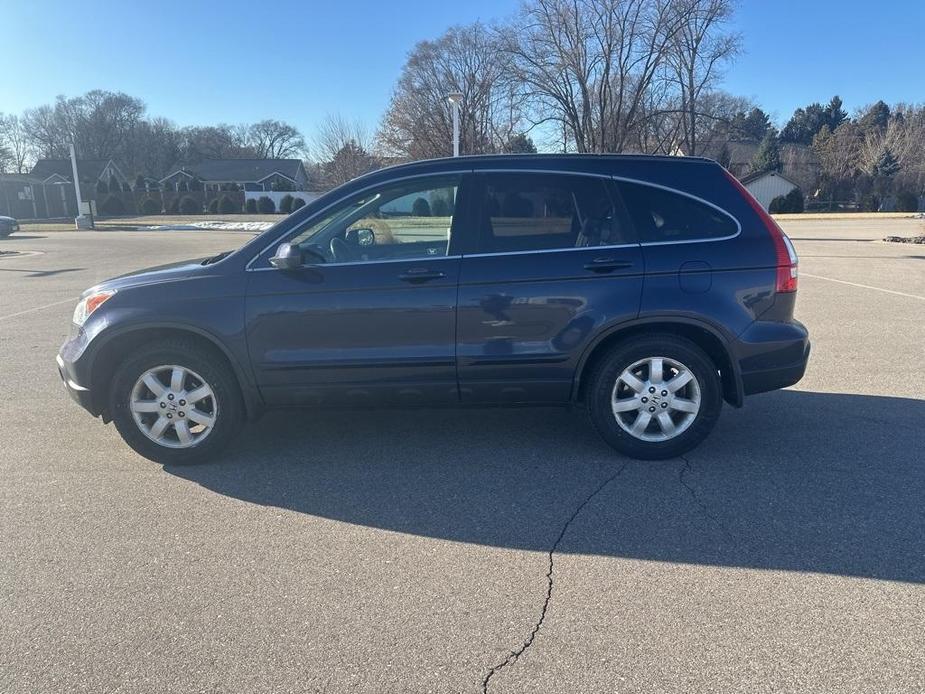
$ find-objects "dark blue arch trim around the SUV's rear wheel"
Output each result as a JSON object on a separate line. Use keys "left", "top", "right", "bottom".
{"left": 572, "top": 316, "right": 745, "bottom": 407}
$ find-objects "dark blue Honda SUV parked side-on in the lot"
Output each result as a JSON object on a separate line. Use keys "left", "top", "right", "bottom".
{"left": 58, "top": 155, "right": 809, "bottom": 463}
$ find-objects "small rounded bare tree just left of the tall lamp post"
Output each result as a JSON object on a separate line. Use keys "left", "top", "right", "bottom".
{"left": 312, "top": 114, "right": 379, "bottom": 187}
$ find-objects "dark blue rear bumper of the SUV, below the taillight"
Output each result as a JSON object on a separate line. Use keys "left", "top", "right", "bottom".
{"left": 737, "top": 321, "right": 810, "bottom": 395}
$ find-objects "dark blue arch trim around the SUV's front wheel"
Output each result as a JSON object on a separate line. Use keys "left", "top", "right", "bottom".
{"left": 89, "top": 324, "right": 263, "bottom": 422}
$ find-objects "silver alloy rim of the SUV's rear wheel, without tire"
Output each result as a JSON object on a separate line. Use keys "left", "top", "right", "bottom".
{"left": 610, "top": 357, "right": 700, "bottom": 442}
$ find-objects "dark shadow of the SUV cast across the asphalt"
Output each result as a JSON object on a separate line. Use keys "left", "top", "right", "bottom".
{"left": 165, "top": 391, "right": 925, "bottom": 583}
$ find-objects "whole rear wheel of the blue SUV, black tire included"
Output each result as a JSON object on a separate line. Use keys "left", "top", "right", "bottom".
{"left": 586, "top": 334, "right": 723, "bottom": 460}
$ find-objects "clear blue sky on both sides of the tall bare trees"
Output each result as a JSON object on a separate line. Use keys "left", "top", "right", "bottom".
{"left": 0, "top": 0, "right": 925, "bottom": 139}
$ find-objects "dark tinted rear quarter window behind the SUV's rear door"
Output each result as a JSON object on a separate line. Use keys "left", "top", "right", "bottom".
{"left": 619, "top": 181, "right": 739, "bottom": 243}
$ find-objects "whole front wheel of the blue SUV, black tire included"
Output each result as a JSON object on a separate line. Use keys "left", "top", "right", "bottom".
{"left": 109, "top": 340, "right": 244, "bottom": 465}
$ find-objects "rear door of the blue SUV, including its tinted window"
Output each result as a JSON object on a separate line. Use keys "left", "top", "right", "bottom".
{"left": 456, "top": 173, "right": 644, "bottom": 404}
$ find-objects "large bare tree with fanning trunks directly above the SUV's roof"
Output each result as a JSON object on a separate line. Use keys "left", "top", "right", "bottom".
{"left": 504, "top": 0, "right": 678, "bottom": 152}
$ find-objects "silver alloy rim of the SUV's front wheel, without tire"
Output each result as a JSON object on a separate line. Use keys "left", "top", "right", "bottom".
{"left": 129, "top": 364, "right": 218, "bottom": 448}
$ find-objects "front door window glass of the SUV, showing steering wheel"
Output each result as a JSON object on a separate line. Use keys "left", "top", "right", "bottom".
{"left": 290, "top": 176, "right": 460, "bottom": 263}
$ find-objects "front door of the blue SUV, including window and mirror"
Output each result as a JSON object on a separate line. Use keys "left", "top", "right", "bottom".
{"left": 246, "top": 176, "right": 470, "bottom": 406}
